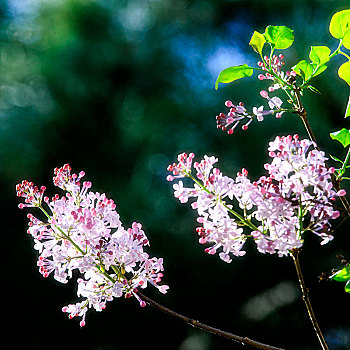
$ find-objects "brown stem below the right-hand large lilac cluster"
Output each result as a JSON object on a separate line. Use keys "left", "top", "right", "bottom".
{"left": 291, "top": 248, "right": 329, "bottom": 350}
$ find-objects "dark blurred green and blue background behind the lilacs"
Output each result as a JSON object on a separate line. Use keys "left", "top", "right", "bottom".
{"left": 0, "top": 0, "right": 350, "bottom": 350}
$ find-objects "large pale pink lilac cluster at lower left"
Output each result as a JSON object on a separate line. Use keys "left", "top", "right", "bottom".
{"left": 16, "top": 164, "right": 168, "bottom": 326}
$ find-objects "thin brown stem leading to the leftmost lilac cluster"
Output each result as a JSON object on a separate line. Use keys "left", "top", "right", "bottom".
{"left": 135, "top": 291, "right": 283, "bottom": 350}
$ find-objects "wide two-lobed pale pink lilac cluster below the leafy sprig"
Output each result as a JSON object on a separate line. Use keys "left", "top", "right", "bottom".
{"left": 167, "top": 135, "right": 345, "bottom": 262}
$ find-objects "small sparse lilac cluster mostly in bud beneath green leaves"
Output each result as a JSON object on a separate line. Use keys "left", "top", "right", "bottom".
{"left": 216, "top": 55, "right": 296, "bottom": 134}
